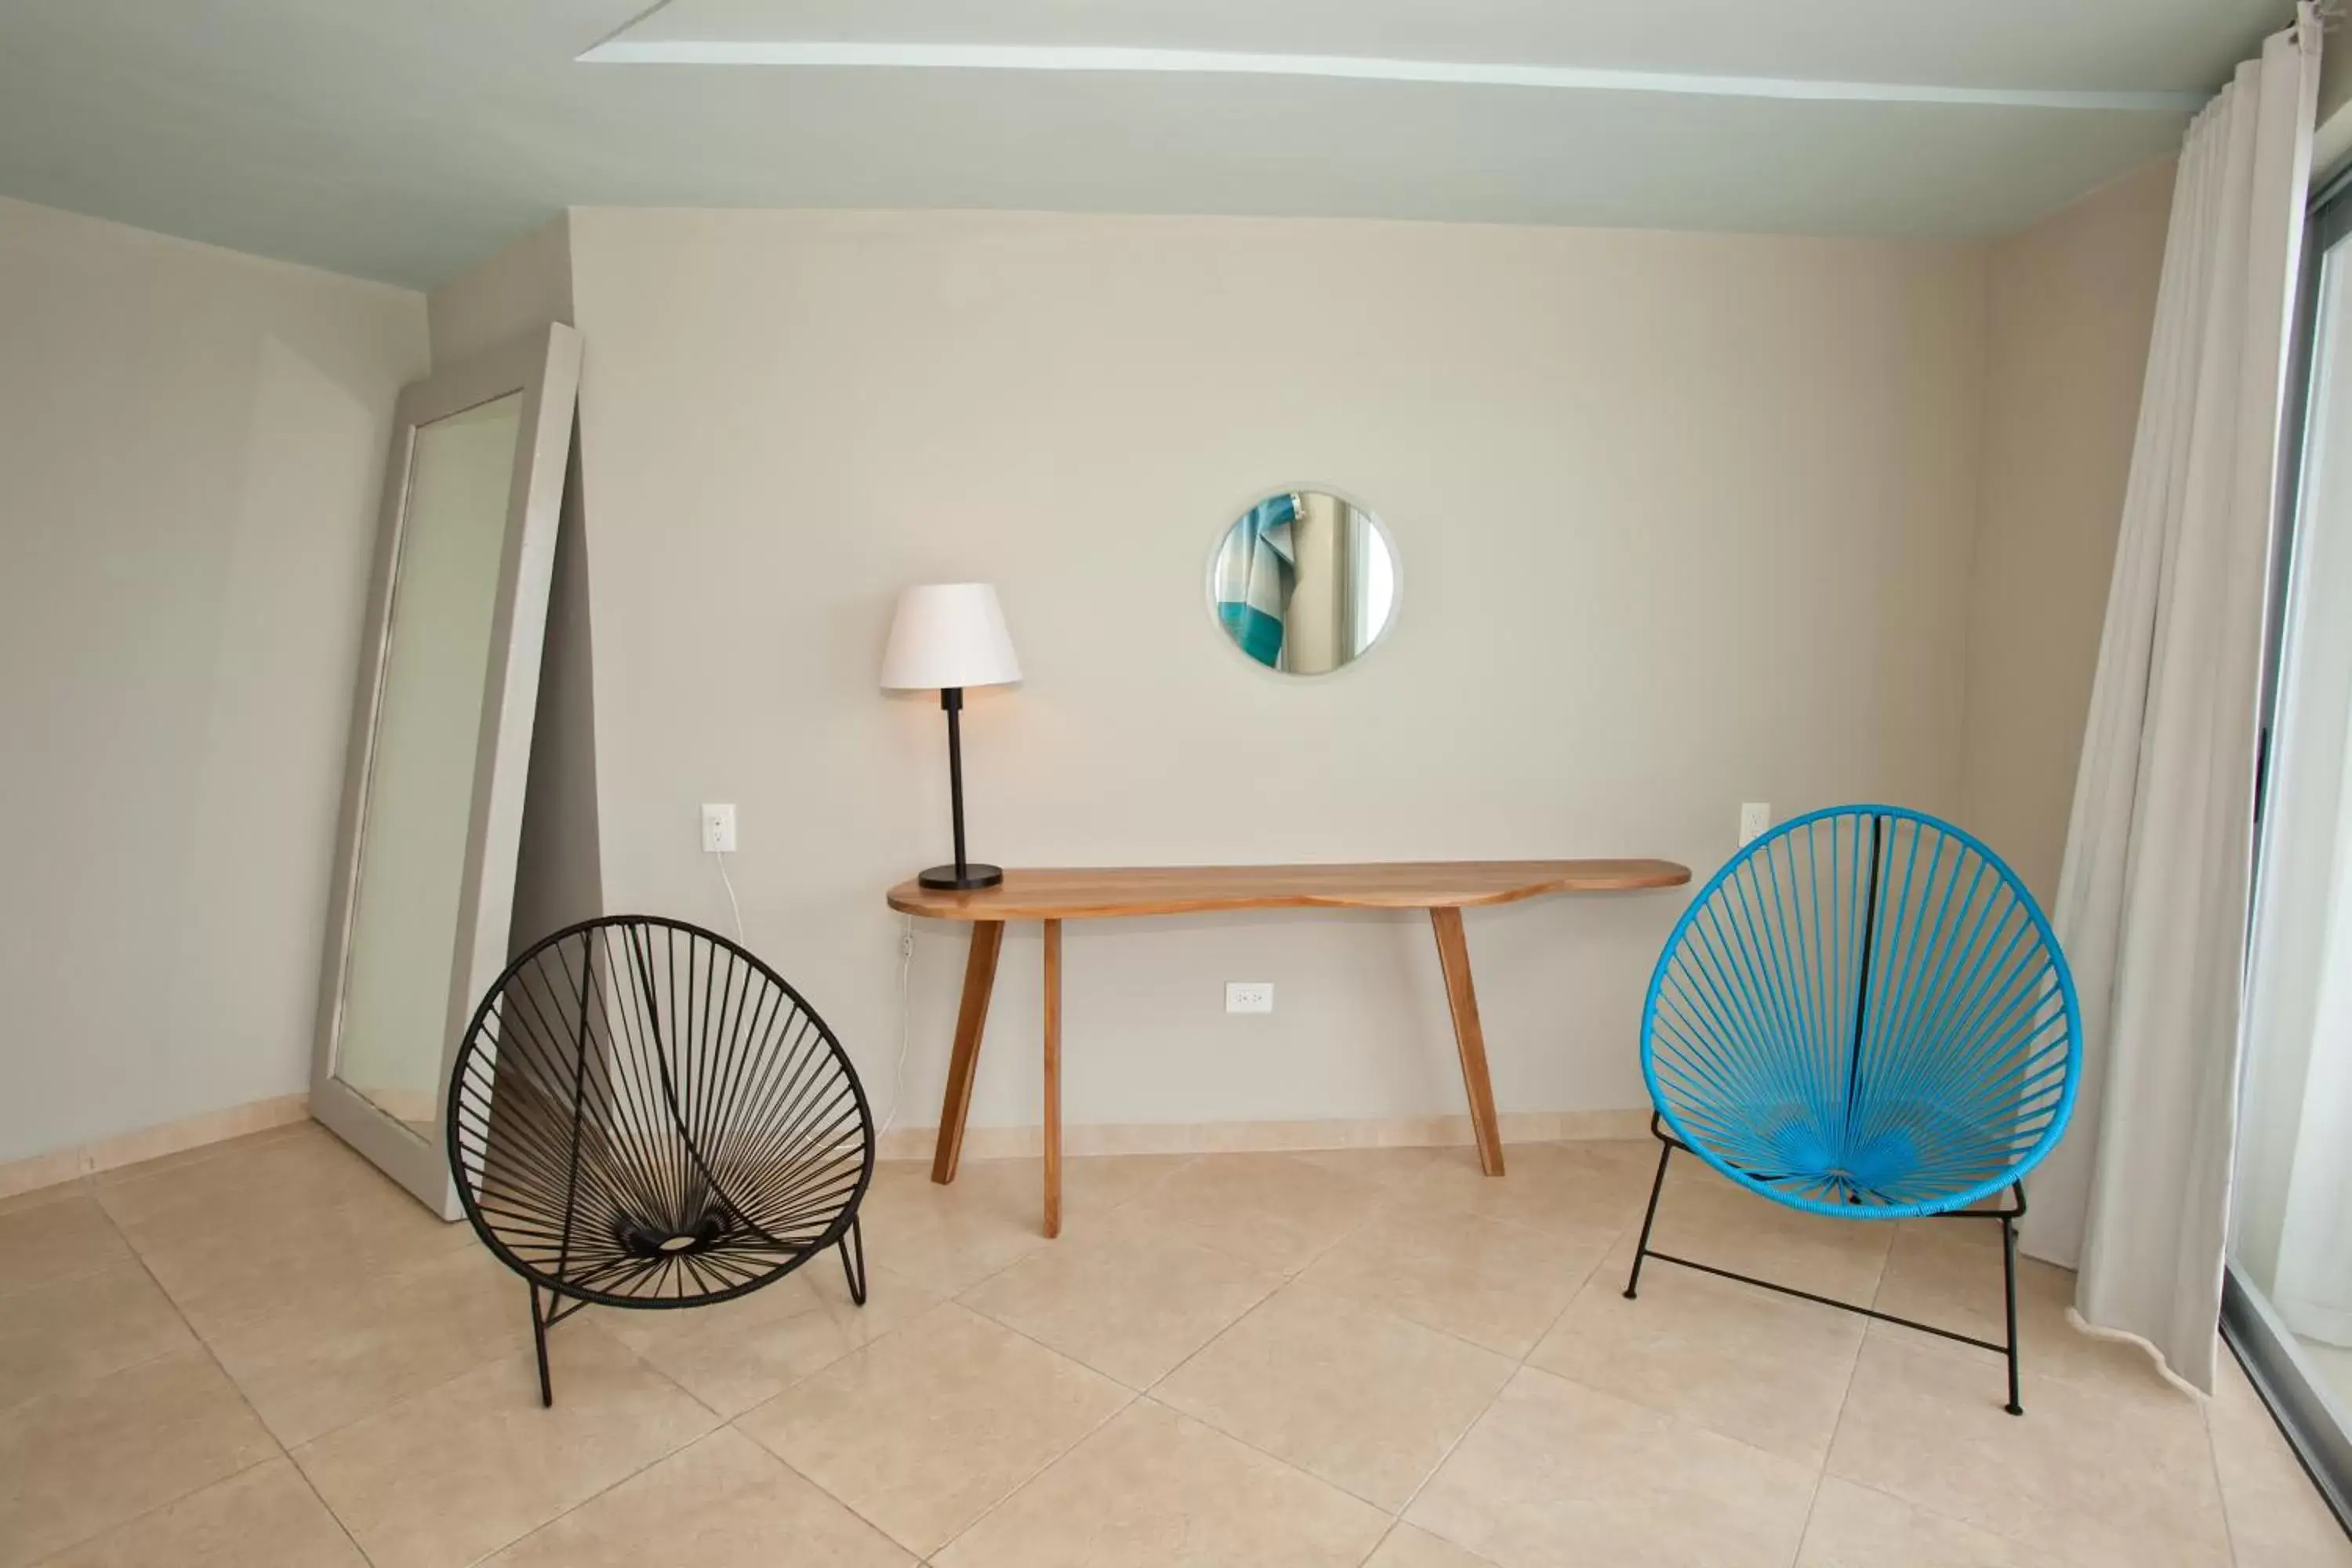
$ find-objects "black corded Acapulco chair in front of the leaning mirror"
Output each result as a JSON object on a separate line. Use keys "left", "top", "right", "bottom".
{"left": 447, "top": 914, "right": 875, "bottom": 1406}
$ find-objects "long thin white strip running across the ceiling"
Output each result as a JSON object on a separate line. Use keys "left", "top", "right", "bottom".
{"left": 579, "top": 38, "right": 2211, "bottom": 115}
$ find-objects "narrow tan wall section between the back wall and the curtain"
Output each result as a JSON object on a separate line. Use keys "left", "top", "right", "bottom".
{"left": 1962, "top": 158, "right": 2173, "bottom": 905}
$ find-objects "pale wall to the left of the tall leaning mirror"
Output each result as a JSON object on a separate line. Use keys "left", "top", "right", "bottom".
{"left": 0, "top": 200, "right": 426, "bottom": 1159}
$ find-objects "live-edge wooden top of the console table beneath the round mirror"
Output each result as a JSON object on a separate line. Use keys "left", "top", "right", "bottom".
{"left": 889, "top": 860, "right": 1691, "bottom": 919}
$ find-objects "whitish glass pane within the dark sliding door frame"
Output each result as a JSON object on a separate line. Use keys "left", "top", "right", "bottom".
{"left": 2232, "top": 247, "right": 2352, "bottom": 1345}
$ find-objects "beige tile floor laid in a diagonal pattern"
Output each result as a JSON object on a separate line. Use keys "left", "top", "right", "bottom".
{"left": 0, "top": 1126, "right": 2352, "bottom": 1568}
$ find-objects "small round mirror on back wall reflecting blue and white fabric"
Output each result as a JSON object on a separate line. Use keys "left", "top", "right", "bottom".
{"left": 1209, "top": 489, "right": 1397, "bottom": 675}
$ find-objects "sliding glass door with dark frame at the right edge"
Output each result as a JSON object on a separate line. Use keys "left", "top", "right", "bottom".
{"left": 2223, "top": 181, "right": 2352, "bottom": 1516}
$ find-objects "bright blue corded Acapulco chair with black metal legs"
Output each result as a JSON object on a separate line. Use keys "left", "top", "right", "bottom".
{"left": 1625, "top": 806, "right": 2082, "bottom": 1415}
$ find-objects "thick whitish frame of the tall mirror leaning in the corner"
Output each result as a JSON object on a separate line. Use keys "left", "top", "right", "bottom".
{"left": 310, "top": 325, "right": 581, "bottom": 1220}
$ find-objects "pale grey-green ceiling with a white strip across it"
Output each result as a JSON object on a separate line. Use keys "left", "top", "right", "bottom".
{"left": 0, "top": 0, "right": 2293, "bottom": 287}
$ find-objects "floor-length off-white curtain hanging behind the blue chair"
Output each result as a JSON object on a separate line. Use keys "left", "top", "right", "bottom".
{"left": 2025, "top": 2, "right": 2319, "bottom": 1389}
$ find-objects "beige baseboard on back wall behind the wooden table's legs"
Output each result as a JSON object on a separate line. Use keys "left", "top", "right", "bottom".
{"left": 880, "top": 1109, "right": 1649, "bottom": 1159}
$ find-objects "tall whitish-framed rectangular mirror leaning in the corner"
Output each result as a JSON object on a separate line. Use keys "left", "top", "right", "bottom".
{"left": 310, "top": 327, "right": 581, "bottom": 1220}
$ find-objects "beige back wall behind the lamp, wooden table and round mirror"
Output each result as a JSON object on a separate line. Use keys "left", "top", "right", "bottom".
{"left": 572, "top": 209, "right": 1985, "bottom": 1142}
